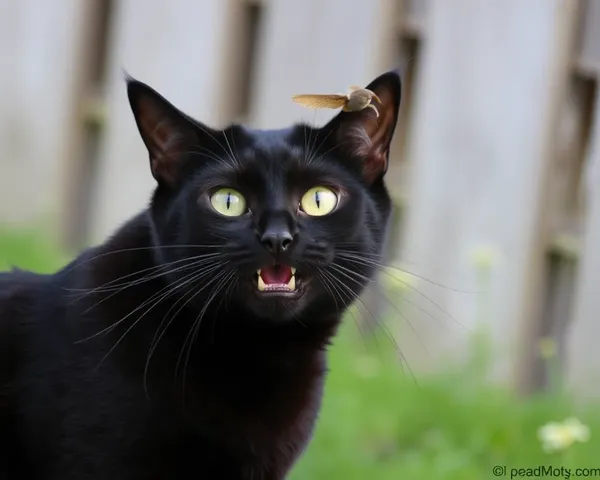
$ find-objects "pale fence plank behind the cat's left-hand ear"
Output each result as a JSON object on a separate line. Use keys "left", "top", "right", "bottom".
{"left": 91, "top": 0, "right": 246, "bottom": 241}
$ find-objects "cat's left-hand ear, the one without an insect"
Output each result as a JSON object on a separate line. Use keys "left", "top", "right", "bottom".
{"left": 126, "top": 76, "right": 200, "bottom": 185}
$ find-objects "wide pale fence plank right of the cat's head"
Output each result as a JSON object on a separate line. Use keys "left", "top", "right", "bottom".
{"left": 392, "top": 0, "right": 574, "bottom": 378}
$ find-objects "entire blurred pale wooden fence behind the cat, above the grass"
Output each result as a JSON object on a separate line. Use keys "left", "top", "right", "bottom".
{"left": 0, "top": 0, "right": 600, "bottom": 394}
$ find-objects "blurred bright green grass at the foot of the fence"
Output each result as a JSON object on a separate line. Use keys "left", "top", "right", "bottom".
{"left": 0, "top": 230, "right": 600, "bottom": 480}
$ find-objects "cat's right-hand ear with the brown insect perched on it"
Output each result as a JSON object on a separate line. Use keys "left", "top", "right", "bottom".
{"left": 324, "top": 70, "right": 402, "bottom": 184}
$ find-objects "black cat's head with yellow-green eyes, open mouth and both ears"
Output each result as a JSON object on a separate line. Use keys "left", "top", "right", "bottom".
{"left": 128, "top": 71, "right": 401, "bottom": 322}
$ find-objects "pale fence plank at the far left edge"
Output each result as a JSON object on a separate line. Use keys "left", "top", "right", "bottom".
{"left": 0, "top": 0, "right": 88, "bottom": 234}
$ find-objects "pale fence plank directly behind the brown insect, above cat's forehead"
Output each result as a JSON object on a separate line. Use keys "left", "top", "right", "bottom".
{"left": 246, "top": 0, "right": 394, "bottom": 128}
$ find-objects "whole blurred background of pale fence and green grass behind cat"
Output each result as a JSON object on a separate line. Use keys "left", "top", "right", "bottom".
{"left": 0, "top": 0, "right": 600, "bottom": 480}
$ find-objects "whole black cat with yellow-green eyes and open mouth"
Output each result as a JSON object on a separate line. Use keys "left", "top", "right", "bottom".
{"left": 0, "top": 72, "right": 401, "bottom": 480}
